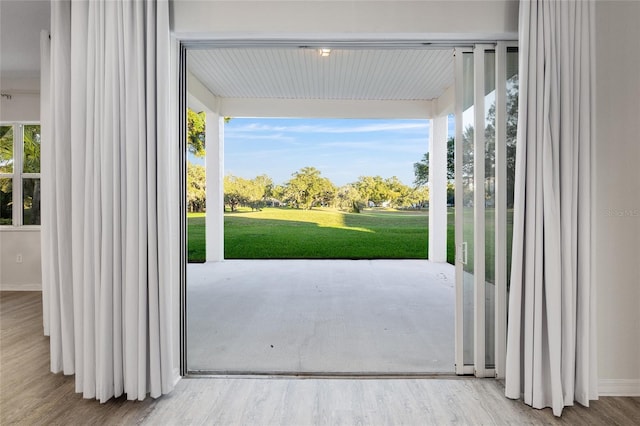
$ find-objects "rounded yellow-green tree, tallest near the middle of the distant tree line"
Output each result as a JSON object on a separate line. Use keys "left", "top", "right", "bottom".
{"left": 285, "top": 167, "right": 335, "bottom": 210}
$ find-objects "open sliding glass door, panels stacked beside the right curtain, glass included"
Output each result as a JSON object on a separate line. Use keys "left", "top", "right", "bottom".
{"left": 455, "top": 42, "right": 517, "bottom": 377}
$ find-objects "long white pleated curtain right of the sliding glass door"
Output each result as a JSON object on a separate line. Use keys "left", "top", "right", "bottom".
{"left": 505, "top": 0, "right": 597, "bottom": 416}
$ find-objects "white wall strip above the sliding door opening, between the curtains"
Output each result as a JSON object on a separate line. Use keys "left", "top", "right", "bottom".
{"left": 172, "top": 0, "right": 518, "bottom": 40}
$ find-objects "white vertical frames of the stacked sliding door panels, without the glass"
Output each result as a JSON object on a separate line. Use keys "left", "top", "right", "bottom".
{"left": 454, "top": 41, "right": 518, "bottom": 379}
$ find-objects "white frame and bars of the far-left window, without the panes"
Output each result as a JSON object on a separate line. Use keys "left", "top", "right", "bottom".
{"left": 0, "top": 120, "right": 42, "bottom": 231}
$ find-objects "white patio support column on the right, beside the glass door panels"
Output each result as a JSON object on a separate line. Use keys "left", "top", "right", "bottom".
{"left": 429, "top": 116, "right": 447, "bottom": 262}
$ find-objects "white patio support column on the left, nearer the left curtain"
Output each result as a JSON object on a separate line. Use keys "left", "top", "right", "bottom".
{"left": 205, "top": 111, "right": 224, "bottom": 262}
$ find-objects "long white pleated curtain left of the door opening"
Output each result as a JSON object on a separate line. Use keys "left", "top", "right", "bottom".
{"left": 42, "top": 0, "right": 179, "bottom": 402}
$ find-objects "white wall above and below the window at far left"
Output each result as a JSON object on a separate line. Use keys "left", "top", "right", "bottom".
{"left": 0, "top": 74, "right": 42, "bottom": 290}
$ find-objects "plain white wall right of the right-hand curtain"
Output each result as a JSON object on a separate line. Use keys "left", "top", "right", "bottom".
{"left": 593, "top": 1, "right": 640, "bottom": 395}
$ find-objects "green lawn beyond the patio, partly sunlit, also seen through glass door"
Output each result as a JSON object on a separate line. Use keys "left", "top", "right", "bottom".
{"left": 187, "top": 208, "right": 512, "bottom": 266}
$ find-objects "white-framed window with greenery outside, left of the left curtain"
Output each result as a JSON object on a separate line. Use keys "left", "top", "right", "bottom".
{"left": 0, "top": 123, "right": 40, "bottom": 226}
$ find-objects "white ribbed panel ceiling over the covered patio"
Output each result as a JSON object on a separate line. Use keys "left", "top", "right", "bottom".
{"left": 188, "top": 47, "right": 454, "bottom": 101}
